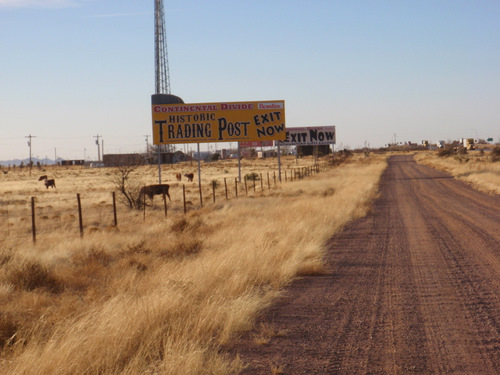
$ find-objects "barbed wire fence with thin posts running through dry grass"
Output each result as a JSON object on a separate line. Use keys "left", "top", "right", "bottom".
{"left": 0, "top": 163, "right": 329, "bottom": 243}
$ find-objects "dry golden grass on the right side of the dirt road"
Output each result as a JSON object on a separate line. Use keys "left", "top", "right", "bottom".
{"left": 415, "top": 151, "right": 500, "bottom": 194}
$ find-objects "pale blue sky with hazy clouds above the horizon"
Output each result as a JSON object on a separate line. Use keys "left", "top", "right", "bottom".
{"left": 0, "top": 0, "right": 500, "bottom": 160}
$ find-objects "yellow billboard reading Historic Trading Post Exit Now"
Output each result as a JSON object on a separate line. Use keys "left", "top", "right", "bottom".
{"left": 152, "top": 100, "right": 286, "bottom": 145}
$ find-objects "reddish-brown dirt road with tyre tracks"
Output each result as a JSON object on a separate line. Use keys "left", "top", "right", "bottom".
{"left": 235, "top": 156, "right": 500, "bottom": 375}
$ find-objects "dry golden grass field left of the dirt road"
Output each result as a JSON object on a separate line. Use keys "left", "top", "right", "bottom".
{"left": 0, "top": 156, "right": 386, "bottom": 374}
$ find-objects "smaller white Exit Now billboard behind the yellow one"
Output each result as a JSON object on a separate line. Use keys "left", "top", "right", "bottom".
{"left": 279, "top": 126, "right": 336, "bottom": 146}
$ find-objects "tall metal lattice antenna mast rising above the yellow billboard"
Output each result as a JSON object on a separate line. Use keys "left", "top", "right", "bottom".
{"left": 155, "top": 0, "right": 170, "bottom": 94}
